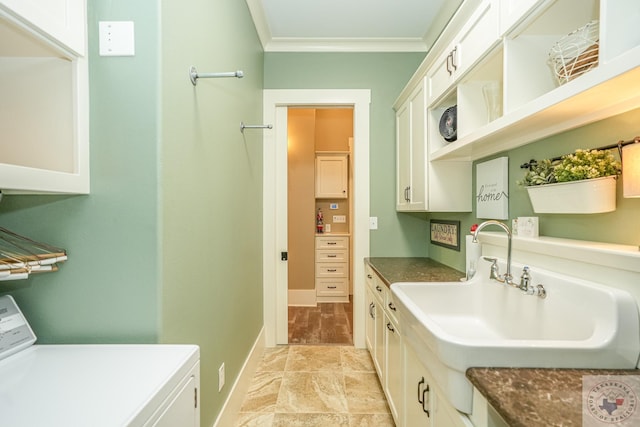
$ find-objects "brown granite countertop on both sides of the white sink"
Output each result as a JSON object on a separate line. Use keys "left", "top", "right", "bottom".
{"left": 365, "top": 257, "right": 640, "bottom": 427}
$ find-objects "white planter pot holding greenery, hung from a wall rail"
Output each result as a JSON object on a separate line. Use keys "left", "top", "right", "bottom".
{"left": 527, "top": 176, "right": 617, "bottom": 214}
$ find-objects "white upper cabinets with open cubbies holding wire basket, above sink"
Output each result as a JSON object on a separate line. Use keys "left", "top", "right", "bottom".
{"left": 395, "top": 0, "right": 640, "bottom": 167}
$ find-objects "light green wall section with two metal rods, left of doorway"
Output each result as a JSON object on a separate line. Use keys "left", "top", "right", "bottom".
{"left": 160, "top": 0, "right": 263, "bottom": 426}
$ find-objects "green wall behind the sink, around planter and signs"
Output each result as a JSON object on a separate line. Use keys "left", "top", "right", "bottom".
{"left": 427, "top": 109, "right": 640, "bottom": 271}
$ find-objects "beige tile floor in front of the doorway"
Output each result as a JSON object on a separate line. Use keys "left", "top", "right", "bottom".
{"left": 236, "top": 345, "right": 395, "bottom": 427}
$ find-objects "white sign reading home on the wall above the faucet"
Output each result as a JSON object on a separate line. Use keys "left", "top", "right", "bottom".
{"left": 476, "top": 157, "right": 509, "bottom": 219}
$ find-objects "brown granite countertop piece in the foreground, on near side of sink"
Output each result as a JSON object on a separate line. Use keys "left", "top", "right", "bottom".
{"left": 467, "top": 368, "right": 640, "bottom": 427}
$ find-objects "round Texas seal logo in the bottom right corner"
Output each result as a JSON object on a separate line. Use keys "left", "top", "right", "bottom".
{"left": 587, "top": 380, "right": 638, "bottom": 424}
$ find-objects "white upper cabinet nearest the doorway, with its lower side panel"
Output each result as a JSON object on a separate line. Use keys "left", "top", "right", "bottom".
{"left": 396, "top": 78, "right": 471, "bottom": 212}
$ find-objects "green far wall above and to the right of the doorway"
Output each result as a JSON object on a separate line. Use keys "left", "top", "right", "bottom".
{"left": 264, "top": 53, "right": 428, "bottom": 256}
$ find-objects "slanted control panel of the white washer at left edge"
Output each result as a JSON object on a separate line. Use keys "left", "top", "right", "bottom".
{"left": 0, "top": 295, "right": 36, "bottom": 359}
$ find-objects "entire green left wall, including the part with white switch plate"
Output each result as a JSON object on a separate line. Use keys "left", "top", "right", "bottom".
{"left": 0, "top": 0, "right": 263, "bottom": 426}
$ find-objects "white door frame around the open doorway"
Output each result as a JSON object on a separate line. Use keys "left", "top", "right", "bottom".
{"left": 262, "top": 89, "right": 371, "bottom": 348}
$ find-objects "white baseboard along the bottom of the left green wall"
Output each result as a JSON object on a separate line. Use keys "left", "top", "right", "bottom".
{"left": 213, "top": 327, "right": 265, "bottom": 427}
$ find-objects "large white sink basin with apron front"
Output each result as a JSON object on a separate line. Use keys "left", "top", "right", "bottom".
{"left": 391, "top": 268, "right": 640, "bottom": 413}
